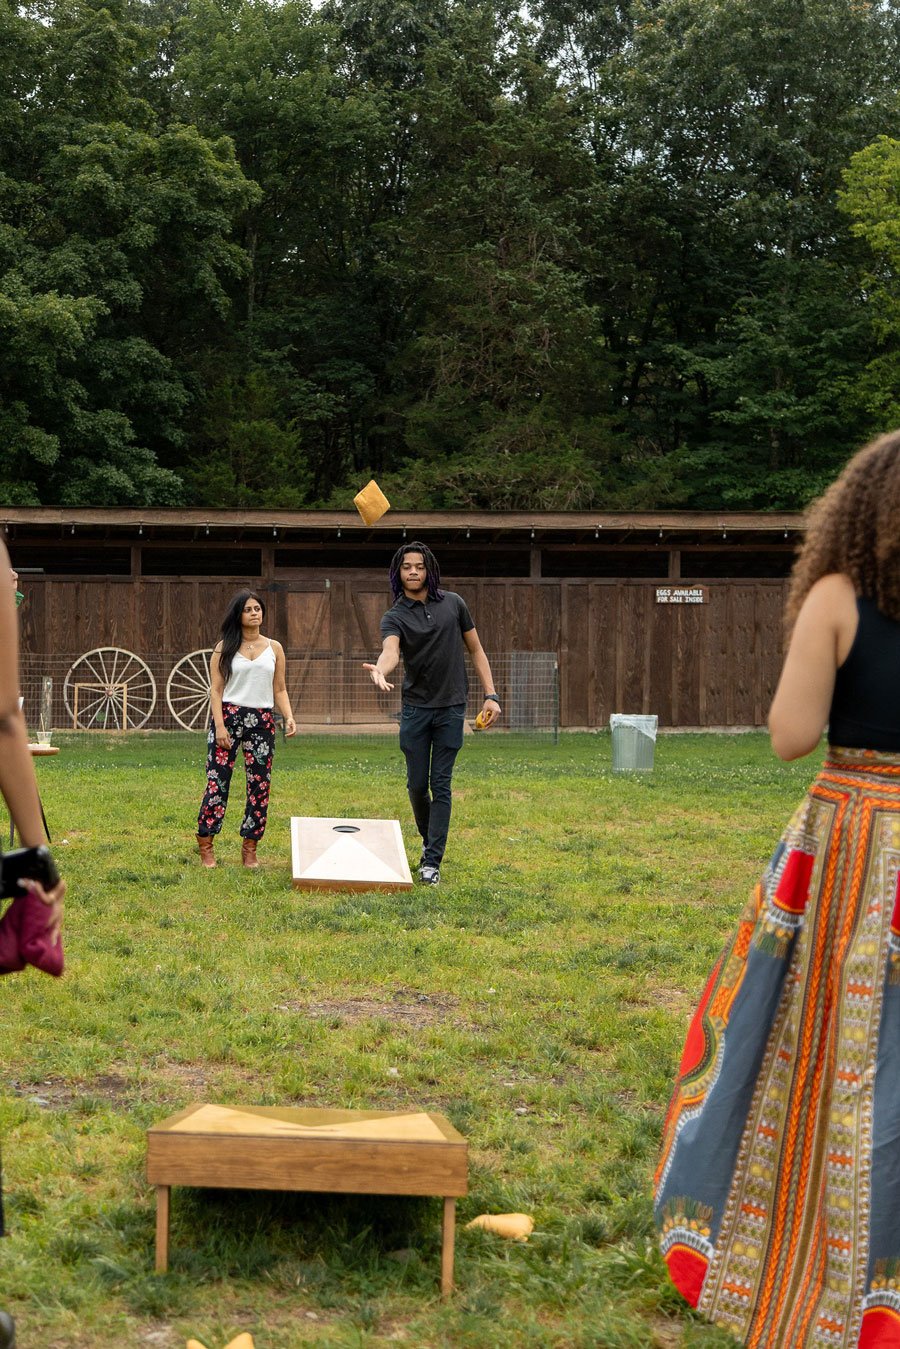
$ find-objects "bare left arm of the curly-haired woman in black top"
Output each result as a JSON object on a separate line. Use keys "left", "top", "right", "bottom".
{"left": 769, "top": 575, "right": 858, "bottom": 759}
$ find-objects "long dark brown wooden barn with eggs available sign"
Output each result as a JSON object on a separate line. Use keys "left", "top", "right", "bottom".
{"left": 0, "top": 507, "right": 803, "bottom": 728}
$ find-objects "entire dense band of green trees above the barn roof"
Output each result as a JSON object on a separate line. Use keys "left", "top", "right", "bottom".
{"left": 0, "top": 0, "right": 900, "bottom": 509}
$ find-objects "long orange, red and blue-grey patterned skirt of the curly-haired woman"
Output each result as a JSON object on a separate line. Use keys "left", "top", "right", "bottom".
{"left": 654, "top": 600, "right": 900, "bottom": 1349}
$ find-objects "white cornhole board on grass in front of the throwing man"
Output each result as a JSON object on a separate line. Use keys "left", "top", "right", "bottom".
{"left": 290, "top": 815, "right": 413, "bottom": 890}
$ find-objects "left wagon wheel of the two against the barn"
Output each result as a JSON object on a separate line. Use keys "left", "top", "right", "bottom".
{"left": 62, "top": 646, "right": 157, "bottom": 731}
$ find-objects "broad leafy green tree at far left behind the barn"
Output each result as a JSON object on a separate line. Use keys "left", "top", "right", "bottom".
{"left": 0, "top": 0, "right": 252, "bottom": 505}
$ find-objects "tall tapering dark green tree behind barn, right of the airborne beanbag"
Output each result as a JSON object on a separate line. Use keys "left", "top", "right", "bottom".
{"left": 375, "top": 7, "right": 626, "bottom": 506}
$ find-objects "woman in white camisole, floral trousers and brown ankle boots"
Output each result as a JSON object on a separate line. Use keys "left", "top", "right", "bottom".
{"left": 197, "top": 591, "right": 297, "bottom": 867}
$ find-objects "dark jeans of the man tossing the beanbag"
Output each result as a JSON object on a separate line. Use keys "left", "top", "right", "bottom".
{"left": 399, "top": 703, "right": 466, "bottom": 866}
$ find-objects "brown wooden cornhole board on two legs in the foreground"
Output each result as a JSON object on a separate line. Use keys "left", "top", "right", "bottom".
{"left": 147, "top": 1102, "right": 468, "bottom": 1296}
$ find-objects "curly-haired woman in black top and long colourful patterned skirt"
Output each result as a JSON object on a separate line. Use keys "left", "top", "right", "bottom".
{"left": 656, "top": 432, "right": 900, "bottom": 1349}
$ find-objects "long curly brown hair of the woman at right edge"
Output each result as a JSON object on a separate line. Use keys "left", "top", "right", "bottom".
{"left": 784, "top": 430, "right": 900, "bottom": 633}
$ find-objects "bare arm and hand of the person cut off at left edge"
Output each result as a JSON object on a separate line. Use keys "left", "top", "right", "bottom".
{"left": 0, "top": 542, "right": 66, "bottom": 938}
